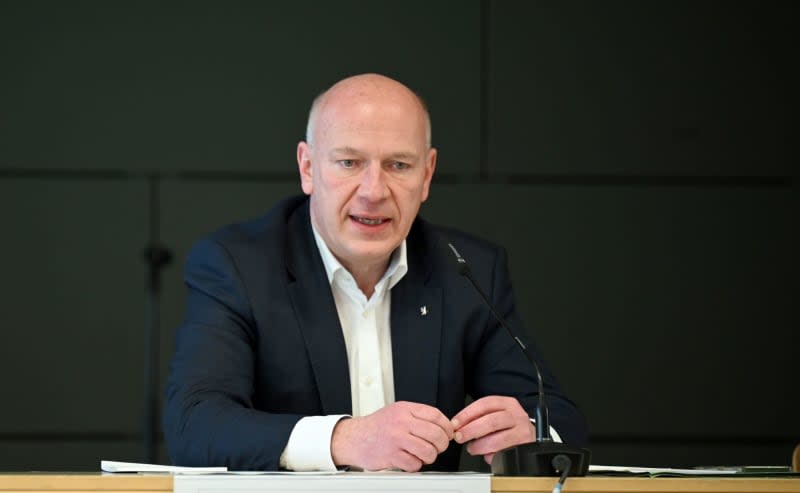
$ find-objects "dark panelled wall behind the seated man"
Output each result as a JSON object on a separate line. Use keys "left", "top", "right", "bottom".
{"left": 0, "top": 0, "right": 800, "bottom": 471}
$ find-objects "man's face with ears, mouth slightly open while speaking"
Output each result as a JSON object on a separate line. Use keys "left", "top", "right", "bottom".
{"left": 297, "top": 89, "right": 436, "bottom": 272}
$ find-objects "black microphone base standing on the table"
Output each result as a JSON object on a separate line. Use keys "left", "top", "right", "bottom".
{"left": 492, "top": 442, "right": 592, "bottom": 476}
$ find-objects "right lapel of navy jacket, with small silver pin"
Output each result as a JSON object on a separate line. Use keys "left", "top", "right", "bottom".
{"left": 391, "top": 223, "right": 443, "bottom": 406}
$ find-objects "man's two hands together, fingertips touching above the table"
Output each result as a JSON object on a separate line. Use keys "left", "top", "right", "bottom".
{"left": 331, "top": 396, "right": 536, "bottom": 472}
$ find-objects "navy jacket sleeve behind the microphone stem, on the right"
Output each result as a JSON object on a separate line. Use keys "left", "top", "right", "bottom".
{"left": 471, "top": 248, "right": 588, "bottom": 445}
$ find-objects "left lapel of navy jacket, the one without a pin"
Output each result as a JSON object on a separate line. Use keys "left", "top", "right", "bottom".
{"left": 286, "top": 202, "right": 352, "bottom": 414}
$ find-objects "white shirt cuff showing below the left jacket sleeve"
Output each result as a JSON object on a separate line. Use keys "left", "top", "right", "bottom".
{"left": 280, "top": 414, "right": 350, "bottom": 471}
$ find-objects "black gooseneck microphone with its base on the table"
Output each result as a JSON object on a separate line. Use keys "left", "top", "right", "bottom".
{"left": 447, "top": 242, "right": 591, "bottom": 476}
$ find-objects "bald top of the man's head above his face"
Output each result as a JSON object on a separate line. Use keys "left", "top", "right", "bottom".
{"left": 306, "top": 74, "right": 431, "bottom": 148}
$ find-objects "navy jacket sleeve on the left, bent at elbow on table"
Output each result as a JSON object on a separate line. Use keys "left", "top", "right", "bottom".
{"left": 163, "top": 239, "right": 303, "bottom": 470}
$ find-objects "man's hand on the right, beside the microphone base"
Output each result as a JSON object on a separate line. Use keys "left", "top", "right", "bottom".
{"left": 452, "top": 395, "right": 536, "bottom": 464}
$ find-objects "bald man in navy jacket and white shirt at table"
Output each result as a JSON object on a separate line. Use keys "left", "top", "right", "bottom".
{"left": 164, "top": 74, "right": 586, "bottom": 471}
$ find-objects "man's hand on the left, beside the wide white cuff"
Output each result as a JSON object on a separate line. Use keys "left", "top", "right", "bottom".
{"left": 331, "top": 402, "right": 453, "bottom": 472}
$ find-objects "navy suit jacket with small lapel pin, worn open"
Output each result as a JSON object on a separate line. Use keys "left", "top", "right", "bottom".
{"left": 163, "top": 193, "right": 586, "bottom": 470}
